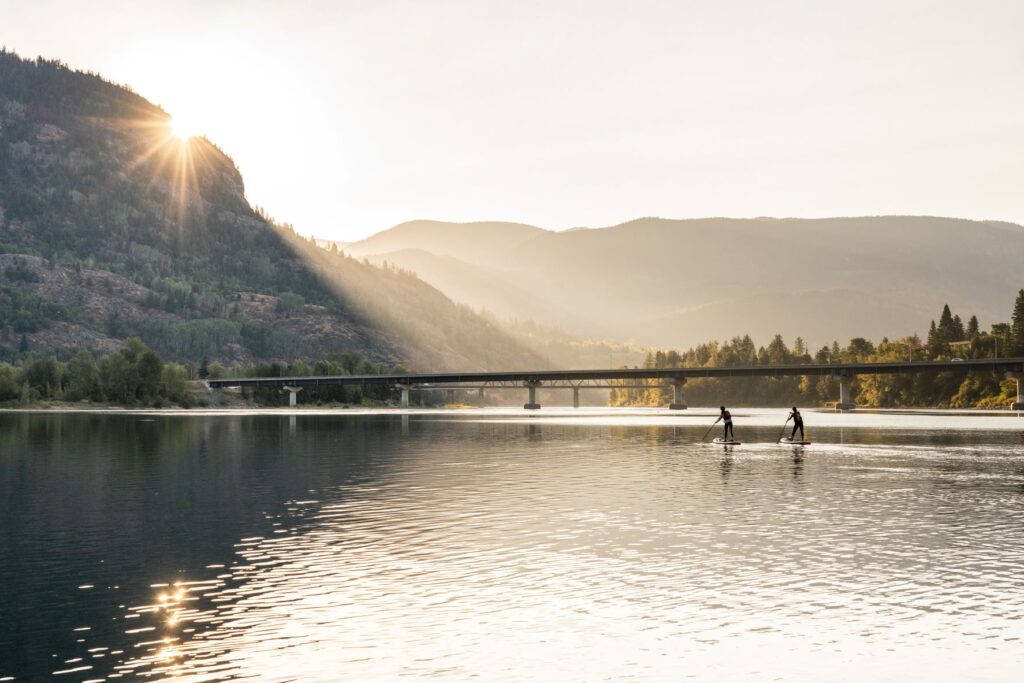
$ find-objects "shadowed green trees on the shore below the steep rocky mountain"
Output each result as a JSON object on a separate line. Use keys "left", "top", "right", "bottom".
{"left": 0, "top": 338, "right": 406, "bottom": 408}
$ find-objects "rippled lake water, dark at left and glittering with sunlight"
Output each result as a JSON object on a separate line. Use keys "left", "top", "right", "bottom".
{"left": 0, "top": 409, "right": 1024, "bottom": 681}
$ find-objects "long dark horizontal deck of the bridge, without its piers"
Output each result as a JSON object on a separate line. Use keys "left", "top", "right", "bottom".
{"left": 206, "top": 358, "right": 1024, "bottom": 389}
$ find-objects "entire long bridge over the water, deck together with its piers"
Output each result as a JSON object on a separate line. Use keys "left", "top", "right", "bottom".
{"left": 206, "top": 358, "right": 1024, "bottom": 411}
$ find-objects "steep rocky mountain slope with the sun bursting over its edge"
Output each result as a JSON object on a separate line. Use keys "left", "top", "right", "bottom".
{"left": 0, "top": 52, "right": 546, "bottom": 370}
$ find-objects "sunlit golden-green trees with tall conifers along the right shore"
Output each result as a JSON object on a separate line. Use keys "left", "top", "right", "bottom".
{"left": 609, "top": 290, "right": 1024, "bottom": 408}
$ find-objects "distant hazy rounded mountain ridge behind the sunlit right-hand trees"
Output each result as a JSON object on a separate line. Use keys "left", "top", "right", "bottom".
{"left": 348, "top": 216, "right": 1024, "bottom": 347}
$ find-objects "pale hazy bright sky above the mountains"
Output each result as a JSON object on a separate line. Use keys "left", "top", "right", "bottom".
{"left": 0, "top": 0, "right": 1024, "bottom": 240}
